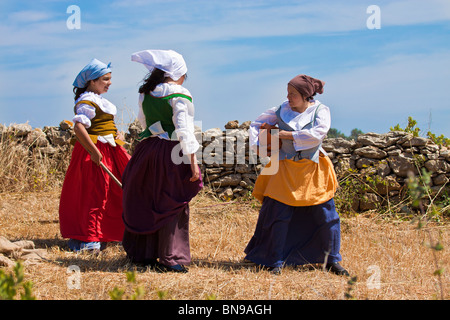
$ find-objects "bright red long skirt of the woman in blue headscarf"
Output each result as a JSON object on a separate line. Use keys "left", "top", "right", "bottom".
{"left": 59, "top": 142, "right": 130, "bottom": 242}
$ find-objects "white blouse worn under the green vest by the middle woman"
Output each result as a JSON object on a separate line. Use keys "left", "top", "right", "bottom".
{"left": 138, "top": 83, "right": 200, "bottom": 155}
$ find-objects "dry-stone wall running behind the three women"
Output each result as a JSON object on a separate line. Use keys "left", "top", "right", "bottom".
{"left": 0, "top": 121, "right": 450, "bottom": 211}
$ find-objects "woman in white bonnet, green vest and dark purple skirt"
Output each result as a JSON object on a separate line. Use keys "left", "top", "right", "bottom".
{"left": 122, "top": 50, "right": 203, "bottom": 272}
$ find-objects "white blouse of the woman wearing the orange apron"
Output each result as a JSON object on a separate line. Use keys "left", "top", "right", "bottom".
{"left": 249, "top": 100, "right": 331, "bottom": 151}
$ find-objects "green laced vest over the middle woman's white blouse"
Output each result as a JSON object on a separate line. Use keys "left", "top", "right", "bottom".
{"left": 139, "top": 93, "right": 192, "bottom": 140}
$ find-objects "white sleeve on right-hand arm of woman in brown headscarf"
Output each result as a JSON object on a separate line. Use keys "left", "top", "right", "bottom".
{"left": 292, "top": 105, "right": 331, "bottom": 151}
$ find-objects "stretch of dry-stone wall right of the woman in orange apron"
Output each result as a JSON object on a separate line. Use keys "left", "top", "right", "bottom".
{"left": 323, "top": 131, "right": 450, "bottom": 211}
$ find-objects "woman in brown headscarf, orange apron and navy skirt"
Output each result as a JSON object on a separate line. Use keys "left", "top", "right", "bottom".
{"left": 245, "top": 75, "right": 348, "bottom": 275}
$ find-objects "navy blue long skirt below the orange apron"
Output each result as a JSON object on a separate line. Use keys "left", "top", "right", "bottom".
{"left": 244, "top": 197, "right": 342, "bottom": 267}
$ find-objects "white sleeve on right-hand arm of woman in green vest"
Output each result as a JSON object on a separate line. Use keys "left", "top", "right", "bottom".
{"left": 170, "top": 97, "right": 200, "bottom": 155}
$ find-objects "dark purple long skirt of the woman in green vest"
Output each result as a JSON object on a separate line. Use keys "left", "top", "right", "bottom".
{"left": 122, "top": 138, "right": 203, "bottom": 266}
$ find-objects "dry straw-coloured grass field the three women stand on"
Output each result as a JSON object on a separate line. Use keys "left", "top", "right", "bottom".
{"left": 0, "top": 188, "right": 450, "bottom": 300}
